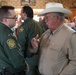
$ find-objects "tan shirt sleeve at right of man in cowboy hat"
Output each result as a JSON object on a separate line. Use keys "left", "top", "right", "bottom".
{"left": 59, "top": 33, "right": 76, "bottom": 75}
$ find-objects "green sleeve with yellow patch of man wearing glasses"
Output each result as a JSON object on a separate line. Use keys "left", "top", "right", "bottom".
{"left": 3, "top": 36, "right": 25, "bottom": 70}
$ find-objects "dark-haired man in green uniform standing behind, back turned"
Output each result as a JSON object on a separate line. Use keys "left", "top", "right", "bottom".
{"left": 18, "top": 6, "right": 43, "bottom": 75}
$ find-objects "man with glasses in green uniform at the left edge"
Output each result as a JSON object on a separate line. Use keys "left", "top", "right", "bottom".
{"left": 0, "top": 6, "right": 26, "bottom": 75}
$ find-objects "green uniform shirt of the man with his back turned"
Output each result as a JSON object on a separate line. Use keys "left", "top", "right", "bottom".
{"left": 18, "top": 18, "right": 43, "bottom": 57}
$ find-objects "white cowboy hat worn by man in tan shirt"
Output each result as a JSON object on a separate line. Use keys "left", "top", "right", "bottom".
{"left": 38, "top": 2, "right": 72, "bottom": 16}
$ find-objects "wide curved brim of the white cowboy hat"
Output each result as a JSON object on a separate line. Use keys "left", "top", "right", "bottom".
{"left": 38, "top": 7, "right": 72, "bottom": 16}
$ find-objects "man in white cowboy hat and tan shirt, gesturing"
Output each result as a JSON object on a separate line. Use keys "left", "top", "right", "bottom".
{"left": 30, "top": 3, "right": 76, "bottom": 75}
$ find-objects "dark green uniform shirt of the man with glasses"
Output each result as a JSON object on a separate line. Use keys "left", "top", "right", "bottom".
{"left": 0, "top": 23, "right": 25, "bottom": 73}
